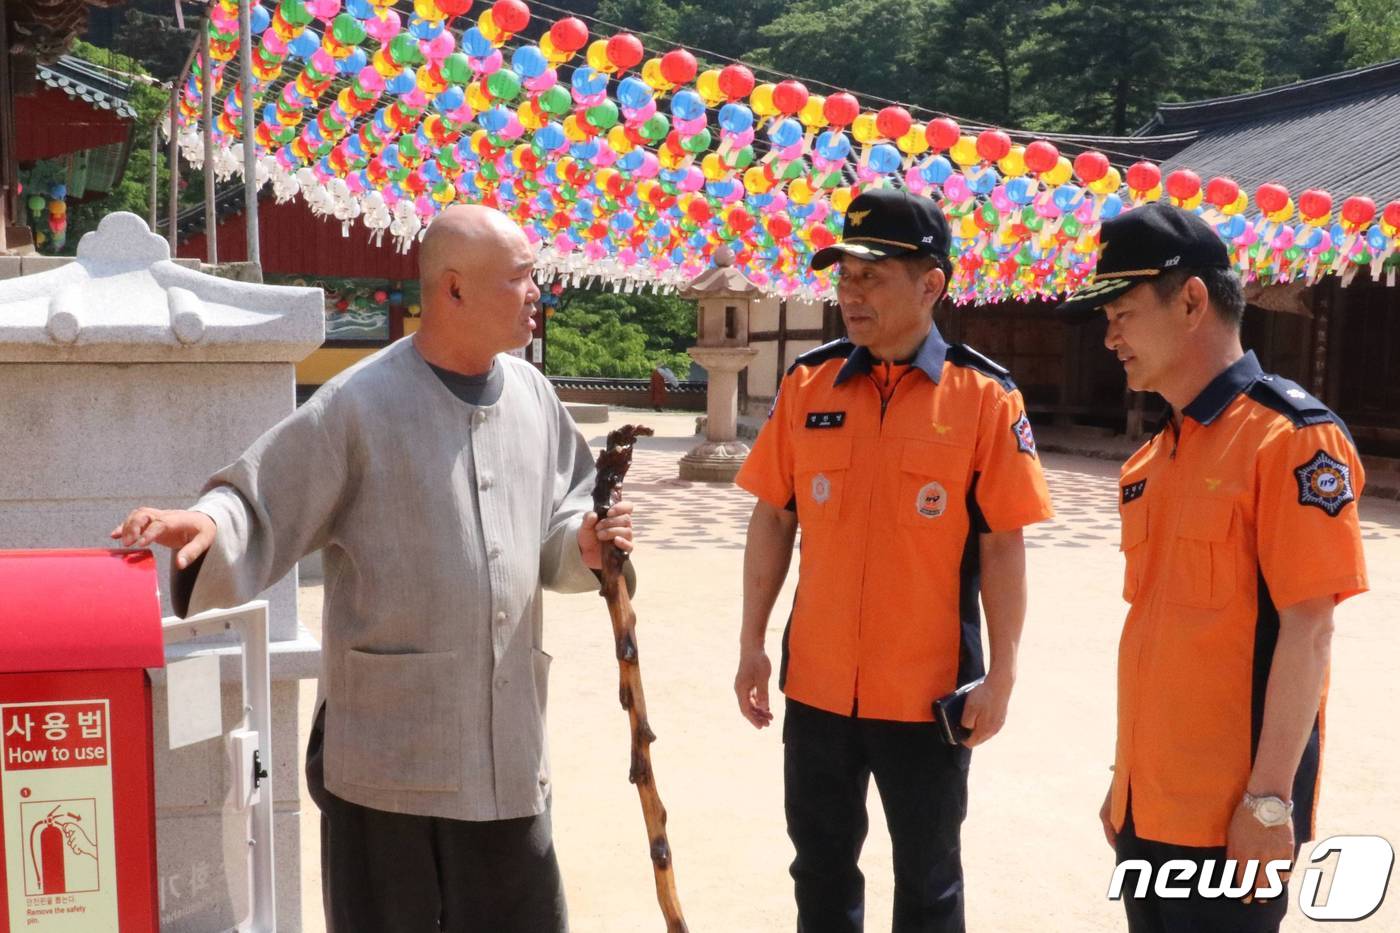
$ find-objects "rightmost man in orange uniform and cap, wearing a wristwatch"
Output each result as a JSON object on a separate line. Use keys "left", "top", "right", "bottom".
{"left": 1061, "top": 205, "right": 1366, "bottom": 933}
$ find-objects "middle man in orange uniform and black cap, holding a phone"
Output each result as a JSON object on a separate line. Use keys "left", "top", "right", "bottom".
{"left": 735, "top": 189, "right": 1051, "bottom": 933}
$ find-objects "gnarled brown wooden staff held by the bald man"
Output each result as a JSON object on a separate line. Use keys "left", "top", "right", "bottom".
{"left": 594, "top": 424, "right": 687, "bottom": 933}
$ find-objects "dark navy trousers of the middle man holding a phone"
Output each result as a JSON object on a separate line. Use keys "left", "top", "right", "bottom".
{"left": 783, "top": 699, "right": 972, "bottom": 933}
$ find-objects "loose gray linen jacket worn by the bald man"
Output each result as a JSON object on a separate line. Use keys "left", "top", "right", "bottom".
{"left": 176, "top": 338, "right": 598, "bottom": 820}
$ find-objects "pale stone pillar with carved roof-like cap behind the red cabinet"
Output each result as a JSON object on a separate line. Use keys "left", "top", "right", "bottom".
{"left": 0, "top": 213, "right": 325, "bottom": 933}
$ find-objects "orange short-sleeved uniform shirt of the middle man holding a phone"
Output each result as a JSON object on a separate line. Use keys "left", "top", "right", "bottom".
{"left": 736, "top": 328, "right": 1051, "bottom": 721}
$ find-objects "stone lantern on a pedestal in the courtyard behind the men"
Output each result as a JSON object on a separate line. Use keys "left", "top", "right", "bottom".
{"left": 680, "top": 256, "right": 762, "bottom": 482}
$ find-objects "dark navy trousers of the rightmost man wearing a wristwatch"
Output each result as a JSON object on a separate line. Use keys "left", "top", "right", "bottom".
{"left": 1117, "top": 801, "right": 1296, "bottom": 933}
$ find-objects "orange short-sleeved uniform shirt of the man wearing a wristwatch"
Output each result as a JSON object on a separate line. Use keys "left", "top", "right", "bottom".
{"left": 1113, "top": 353, "right": 1366, "bottom": 846}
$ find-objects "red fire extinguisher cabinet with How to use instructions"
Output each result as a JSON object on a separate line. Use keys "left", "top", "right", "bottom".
{"left": 0, "top": 551, "right": 165, "bottom": 933}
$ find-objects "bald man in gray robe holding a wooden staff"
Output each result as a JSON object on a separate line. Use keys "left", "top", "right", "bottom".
{"left": 112, "top": 206, "right": 631, "bottom": 933}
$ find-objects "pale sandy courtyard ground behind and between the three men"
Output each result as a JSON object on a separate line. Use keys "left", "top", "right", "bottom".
{"left": 289, "top": 412, "right": 1400, "bottom": 933}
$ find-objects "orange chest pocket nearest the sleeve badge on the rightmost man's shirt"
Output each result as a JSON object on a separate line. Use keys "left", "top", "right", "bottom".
{"left": 1165, "top": 497, "right": 1238, "bottom": 609}
